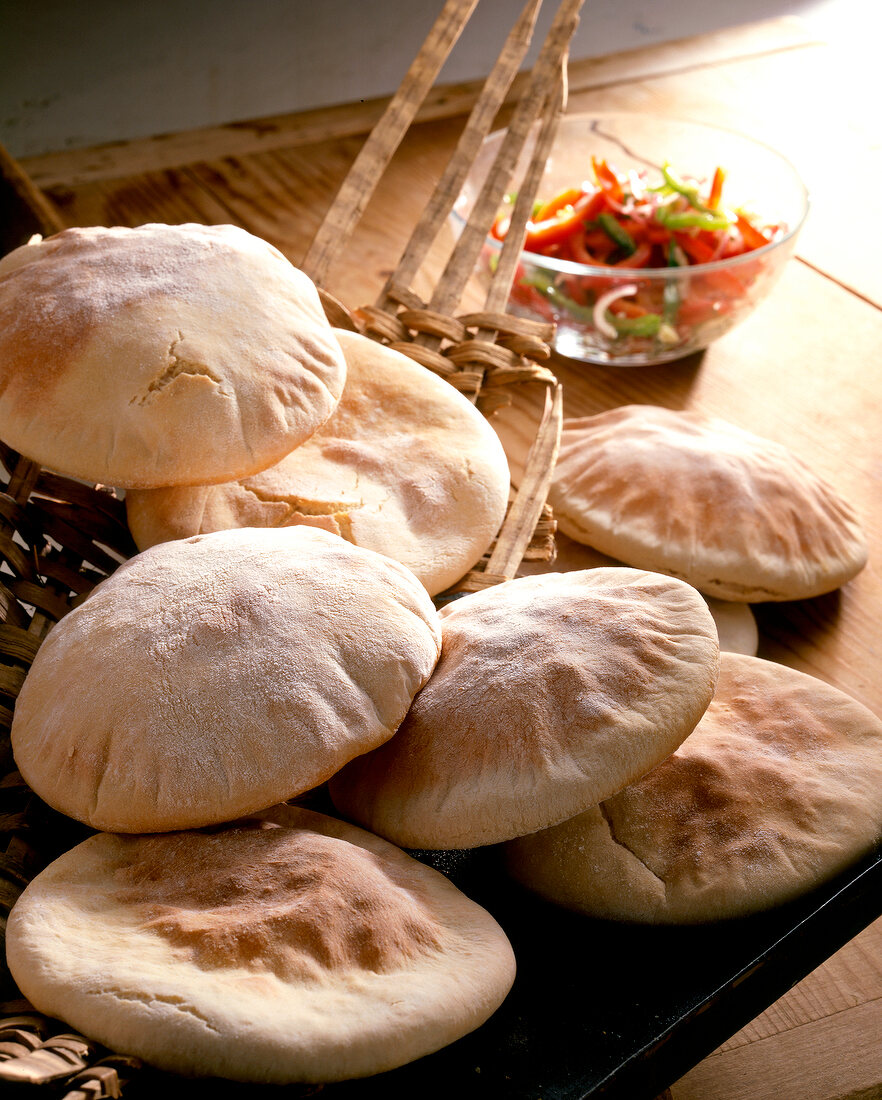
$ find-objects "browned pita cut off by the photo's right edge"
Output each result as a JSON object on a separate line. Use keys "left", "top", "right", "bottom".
{"left": 506, "top": 653, "right": 882, "bottom": 923}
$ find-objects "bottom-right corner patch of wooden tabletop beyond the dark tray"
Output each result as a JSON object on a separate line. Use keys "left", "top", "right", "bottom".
{"left": 670, "top": 921, "right": 882, "bottom": 1100}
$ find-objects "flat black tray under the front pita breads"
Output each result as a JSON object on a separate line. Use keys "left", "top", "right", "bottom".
{"left": 118, "top": 831, "right": 882, "bottom": 1100}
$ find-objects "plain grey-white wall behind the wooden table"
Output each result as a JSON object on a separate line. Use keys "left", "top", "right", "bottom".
{"left": 0, "top": 0, "right": 866, "bottom": 156}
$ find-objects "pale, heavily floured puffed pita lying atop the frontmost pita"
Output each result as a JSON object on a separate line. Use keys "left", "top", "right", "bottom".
{"left": 11, "top": 527, "right": 440, "bottom": 833}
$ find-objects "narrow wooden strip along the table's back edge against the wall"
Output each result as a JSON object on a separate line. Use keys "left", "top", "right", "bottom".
{"left": 15, "top": 17, "right": 813, "bottom": 187}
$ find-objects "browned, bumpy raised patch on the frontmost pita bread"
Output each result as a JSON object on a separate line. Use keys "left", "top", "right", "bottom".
{"left": 117, "top": 823, "right": 441, "bottom": 981}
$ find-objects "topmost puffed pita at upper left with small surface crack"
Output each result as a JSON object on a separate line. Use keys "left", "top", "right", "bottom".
{"left": 0, "top": 224, "right": 345, "bottom": 487}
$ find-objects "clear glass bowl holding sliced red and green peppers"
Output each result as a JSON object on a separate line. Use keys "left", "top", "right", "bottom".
{"left": 451, "top": 113, "right": 808, "bottom": 366}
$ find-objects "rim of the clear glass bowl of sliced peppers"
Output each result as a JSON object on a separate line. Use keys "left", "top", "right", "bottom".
{"left": 451, "top": 111, "right": 809, "bottom": 283}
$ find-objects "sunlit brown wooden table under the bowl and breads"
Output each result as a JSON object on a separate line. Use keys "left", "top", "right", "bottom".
{"left": 15, "top": 14, "right": 882, "bottom": 1100}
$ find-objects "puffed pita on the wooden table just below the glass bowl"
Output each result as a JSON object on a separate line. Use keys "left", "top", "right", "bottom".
{"left": 549, "top": 405, "right": 867, "bottom": 603}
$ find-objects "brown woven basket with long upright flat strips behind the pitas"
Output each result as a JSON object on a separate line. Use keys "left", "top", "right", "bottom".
{"left": 0, "top": 0, "right": 581, "bottom": 1100}
